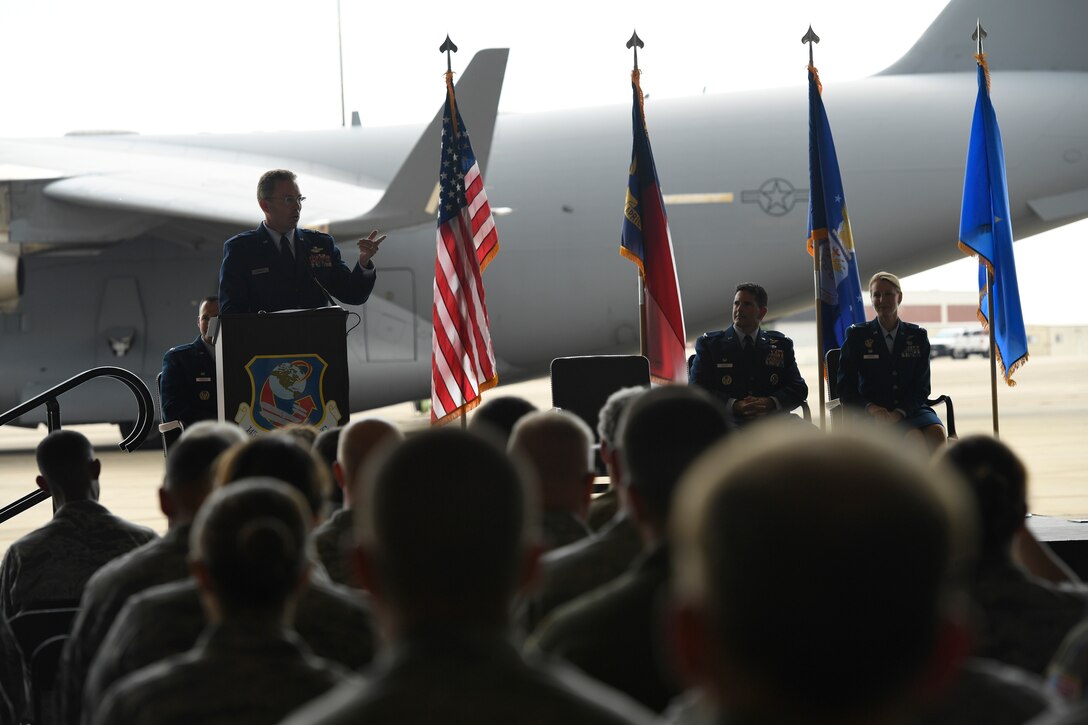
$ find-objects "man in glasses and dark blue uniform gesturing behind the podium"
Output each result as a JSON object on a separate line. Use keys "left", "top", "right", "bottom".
{"left": 219, "top": 169, "right": 385, "bottom": 315}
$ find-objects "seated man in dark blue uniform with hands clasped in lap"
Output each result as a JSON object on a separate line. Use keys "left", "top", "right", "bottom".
{"left": 688, "top": 277, "right": 808, "bottom": 426}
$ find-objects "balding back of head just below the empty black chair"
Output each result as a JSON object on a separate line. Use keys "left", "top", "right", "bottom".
{"left": 509, "top": 410, "right": 593, "bottom": 481}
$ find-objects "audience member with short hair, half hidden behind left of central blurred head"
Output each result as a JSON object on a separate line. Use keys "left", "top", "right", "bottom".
{"left": 313, "top": 418, "right": 404, "bottom": 587}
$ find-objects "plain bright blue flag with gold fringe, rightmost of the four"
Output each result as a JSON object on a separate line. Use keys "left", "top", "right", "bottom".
{"left": 959, "top": 56, "right": 1027, "bottom": 385}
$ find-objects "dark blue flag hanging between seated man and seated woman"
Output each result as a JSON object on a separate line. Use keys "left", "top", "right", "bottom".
{"left": 808, "top": 65, "right": 865, "bottom": 359}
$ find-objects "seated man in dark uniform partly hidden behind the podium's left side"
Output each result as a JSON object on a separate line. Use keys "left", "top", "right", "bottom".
{"left": 162, "top": 297, "right": 219, "bottom": 428}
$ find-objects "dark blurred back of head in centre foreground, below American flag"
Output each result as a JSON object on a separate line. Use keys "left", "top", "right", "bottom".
{"left": 355, "top": 428, "right": 541, "bottom": 612}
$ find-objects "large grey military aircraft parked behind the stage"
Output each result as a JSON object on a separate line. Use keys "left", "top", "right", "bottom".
{"left": 0, "top": 0, "right": 1088, "bottom": 425}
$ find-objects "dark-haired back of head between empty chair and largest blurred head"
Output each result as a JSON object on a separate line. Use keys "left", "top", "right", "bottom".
{"left": 618, "top": 385, "right": 728, "bottom": 525}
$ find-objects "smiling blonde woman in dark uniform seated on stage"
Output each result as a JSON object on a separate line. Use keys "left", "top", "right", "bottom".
{"left": 838, "top": 267, "right": 944, "bottom": 448}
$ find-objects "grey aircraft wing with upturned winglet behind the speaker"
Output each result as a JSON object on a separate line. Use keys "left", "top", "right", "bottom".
{"left": 6, "top": 49, "right": 509, "bottom": 244}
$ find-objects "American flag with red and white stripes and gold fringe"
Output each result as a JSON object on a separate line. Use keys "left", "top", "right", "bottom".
{"left": 431, "top": 73, "right": 498, "bottom": 425}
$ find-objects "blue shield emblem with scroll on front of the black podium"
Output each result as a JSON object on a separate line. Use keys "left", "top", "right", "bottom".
{"left": 234, "top": 355, "right": 341, "bottom": 435}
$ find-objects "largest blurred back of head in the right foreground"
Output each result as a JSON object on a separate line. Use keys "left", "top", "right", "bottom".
{"left": 669, "top": 423, "right": 974, "bottom": 715}
